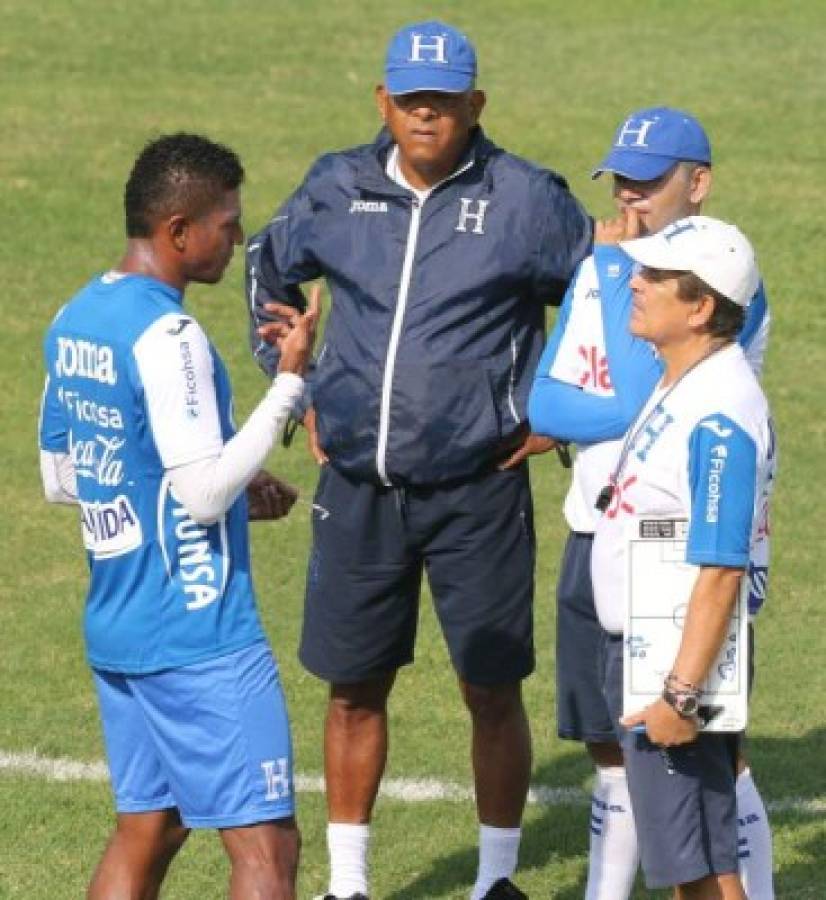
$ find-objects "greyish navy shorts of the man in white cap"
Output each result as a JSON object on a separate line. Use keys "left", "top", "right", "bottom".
{"left": 603, "top": 635, "right": 739, "bottom": 889}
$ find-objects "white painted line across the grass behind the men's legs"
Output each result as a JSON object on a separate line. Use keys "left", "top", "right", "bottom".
{"left": 0, "top": 751, "right": 826, "bottom": 816}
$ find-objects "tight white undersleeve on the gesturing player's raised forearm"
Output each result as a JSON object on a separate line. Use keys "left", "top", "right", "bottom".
{"left": 169, "top": 372, "right": 304, "bottom": 525}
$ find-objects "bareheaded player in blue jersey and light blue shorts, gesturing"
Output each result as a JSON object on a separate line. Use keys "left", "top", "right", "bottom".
{"left": 40, "top": 134, "right": 318, "bottom": 900}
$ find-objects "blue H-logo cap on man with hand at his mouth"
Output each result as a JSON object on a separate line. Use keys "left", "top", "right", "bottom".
{"left": 591, "top": 106, "right": 711, "bottom": 181}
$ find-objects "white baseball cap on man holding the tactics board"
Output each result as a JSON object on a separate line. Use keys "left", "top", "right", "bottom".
{"left": 620, "top": 216, "right": 760, "bottom": 307}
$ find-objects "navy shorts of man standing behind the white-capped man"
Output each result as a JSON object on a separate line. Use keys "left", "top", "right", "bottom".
{"left": 556, "top": 531, "right": 617, "bottom": 743}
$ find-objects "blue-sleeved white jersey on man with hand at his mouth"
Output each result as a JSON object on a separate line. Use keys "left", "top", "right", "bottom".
{"left": 528, "top": 245, "right": 770, "bottom": 533}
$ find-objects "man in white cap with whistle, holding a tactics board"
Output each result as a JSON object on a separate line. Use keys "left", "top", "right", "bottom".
{"left": 591, "top": 216, "right": 776, "bottom": 900}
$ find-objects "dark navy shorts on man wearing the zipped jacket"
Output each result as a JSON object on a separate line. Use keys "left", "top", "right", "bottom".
{"left": 299, "top": 464, "right": 535, "bottom": 685}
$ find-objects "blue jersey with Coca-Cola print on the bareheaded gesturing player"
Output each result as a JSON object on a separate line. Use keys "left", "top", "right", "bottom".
{"left": 40, "top": 273, "right": 263, "bottom": 674}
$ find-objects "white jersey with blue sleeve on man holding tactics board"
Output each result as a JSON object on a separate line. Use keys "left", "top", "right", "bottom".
{"left": 591, "top": 344, "right": 777, "bottom": 634}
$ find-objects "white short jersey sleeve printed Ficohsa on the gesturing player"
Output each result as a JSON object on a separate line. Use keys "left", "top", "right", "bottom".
{"left": 133, "top": 313, "right": 224, "bottom": 469}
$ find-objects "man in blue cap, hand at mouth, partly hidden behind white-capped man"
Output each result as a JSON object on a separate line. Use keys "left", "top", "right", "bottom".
{"left": 529, "top": 106, "right": 773, "bottom": 900}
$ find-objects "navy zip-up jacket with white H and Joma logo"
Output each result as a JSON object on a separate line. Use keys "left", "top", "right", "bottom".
{"left": 247, "top": 129, "right": 593, "bottom": 485}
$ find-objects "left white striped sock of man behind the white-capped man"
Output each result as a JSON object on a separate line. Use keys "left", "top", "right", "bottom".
{"left": 585, "top": 766, "right": 640, "bottom": 900}
